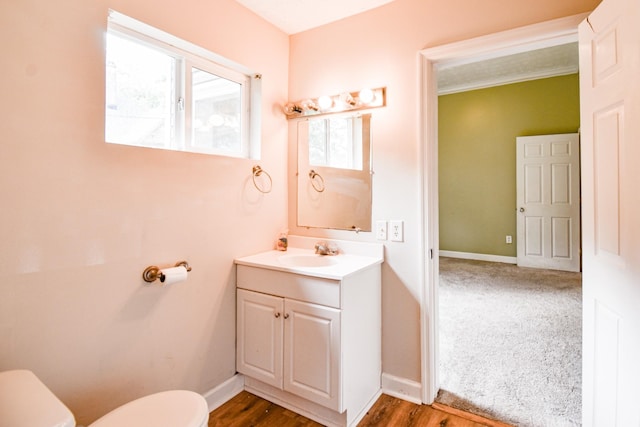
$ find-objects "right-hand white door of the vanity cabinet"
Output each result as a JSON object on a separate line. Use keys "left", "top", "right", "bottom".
{"left": 283, "top": 299, "right": 342, "bottom": 412}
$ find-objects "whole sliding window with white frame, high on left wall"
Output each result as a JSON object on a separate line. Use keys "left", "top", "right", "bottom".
{"left": 105, "top": 11, "right": 260, "bottom": 158}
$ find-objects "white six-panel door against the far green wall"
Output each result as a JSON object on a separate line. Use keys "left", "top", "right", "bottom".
{"left": 516, "top": 133, "right": 580, "bottom": 271}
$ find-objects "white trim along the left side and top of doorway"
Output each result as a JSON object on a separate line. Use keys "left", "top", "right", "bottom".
{"left": 418, "top": 13, "right": 588, "bottom": 404}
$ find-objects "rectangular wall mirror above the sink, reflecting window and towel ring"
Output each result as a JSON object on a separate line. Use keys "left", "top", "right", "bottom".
{"left": 297, "top": 114, "right": 371, "bottom": 231}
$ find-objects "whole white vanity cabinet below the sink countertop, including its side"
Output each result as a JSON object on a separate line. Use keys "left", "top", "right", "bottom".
{"left": 236, "top": 249, "right": 381, "bottom": 426}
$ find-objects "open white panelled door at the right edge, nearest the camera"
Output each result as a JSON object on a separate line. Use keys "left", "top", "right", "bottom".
{"left": 579, "top": 0, "right": 640, "bottom": 427}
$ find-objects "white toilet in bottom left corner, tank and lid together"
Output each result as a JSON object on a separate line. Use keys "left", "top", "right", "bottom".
{"left": 0, "top": 370, "right": 209, "bottom": 427}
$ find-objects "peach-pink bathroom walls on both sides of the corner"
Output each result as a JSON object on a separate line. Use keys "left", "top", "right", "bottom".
{"left": 0, "top": 0, "right": 598, "bottom": 424}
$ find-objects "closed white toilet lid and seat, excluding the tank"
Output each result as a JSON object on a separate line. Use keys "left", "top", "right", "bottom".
{"left": 89, "top": 390, "right": 209, "bottom": 427}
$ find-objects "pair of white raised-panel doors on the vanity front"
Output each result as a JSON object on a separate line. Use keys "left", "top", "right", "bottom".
{"left": 237, "top": 289, "right": 340, "bottom": 411}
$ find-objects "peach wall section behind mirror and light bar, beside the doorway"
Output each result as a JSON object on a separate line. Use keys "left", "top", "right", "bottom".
{"left": 289, "top": 0, "right": 599, "bottom": 381}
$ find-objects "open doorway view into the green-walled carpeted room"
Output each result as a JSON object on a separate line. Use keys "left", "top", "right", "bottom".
{"left": 436, "top": 70, "right": 582, "bottom": 426}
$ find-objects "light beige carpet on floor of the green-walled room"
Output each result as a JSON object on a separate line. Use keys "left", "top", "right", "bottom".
{"left": 436, "top": 257, "right": 582, "bottom": 427}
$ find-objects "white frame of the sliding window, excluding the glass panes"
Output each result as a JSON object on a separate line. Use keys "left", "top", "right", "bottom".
{"left": 107, "top": 9, "right": 262, "bottom": 159}
